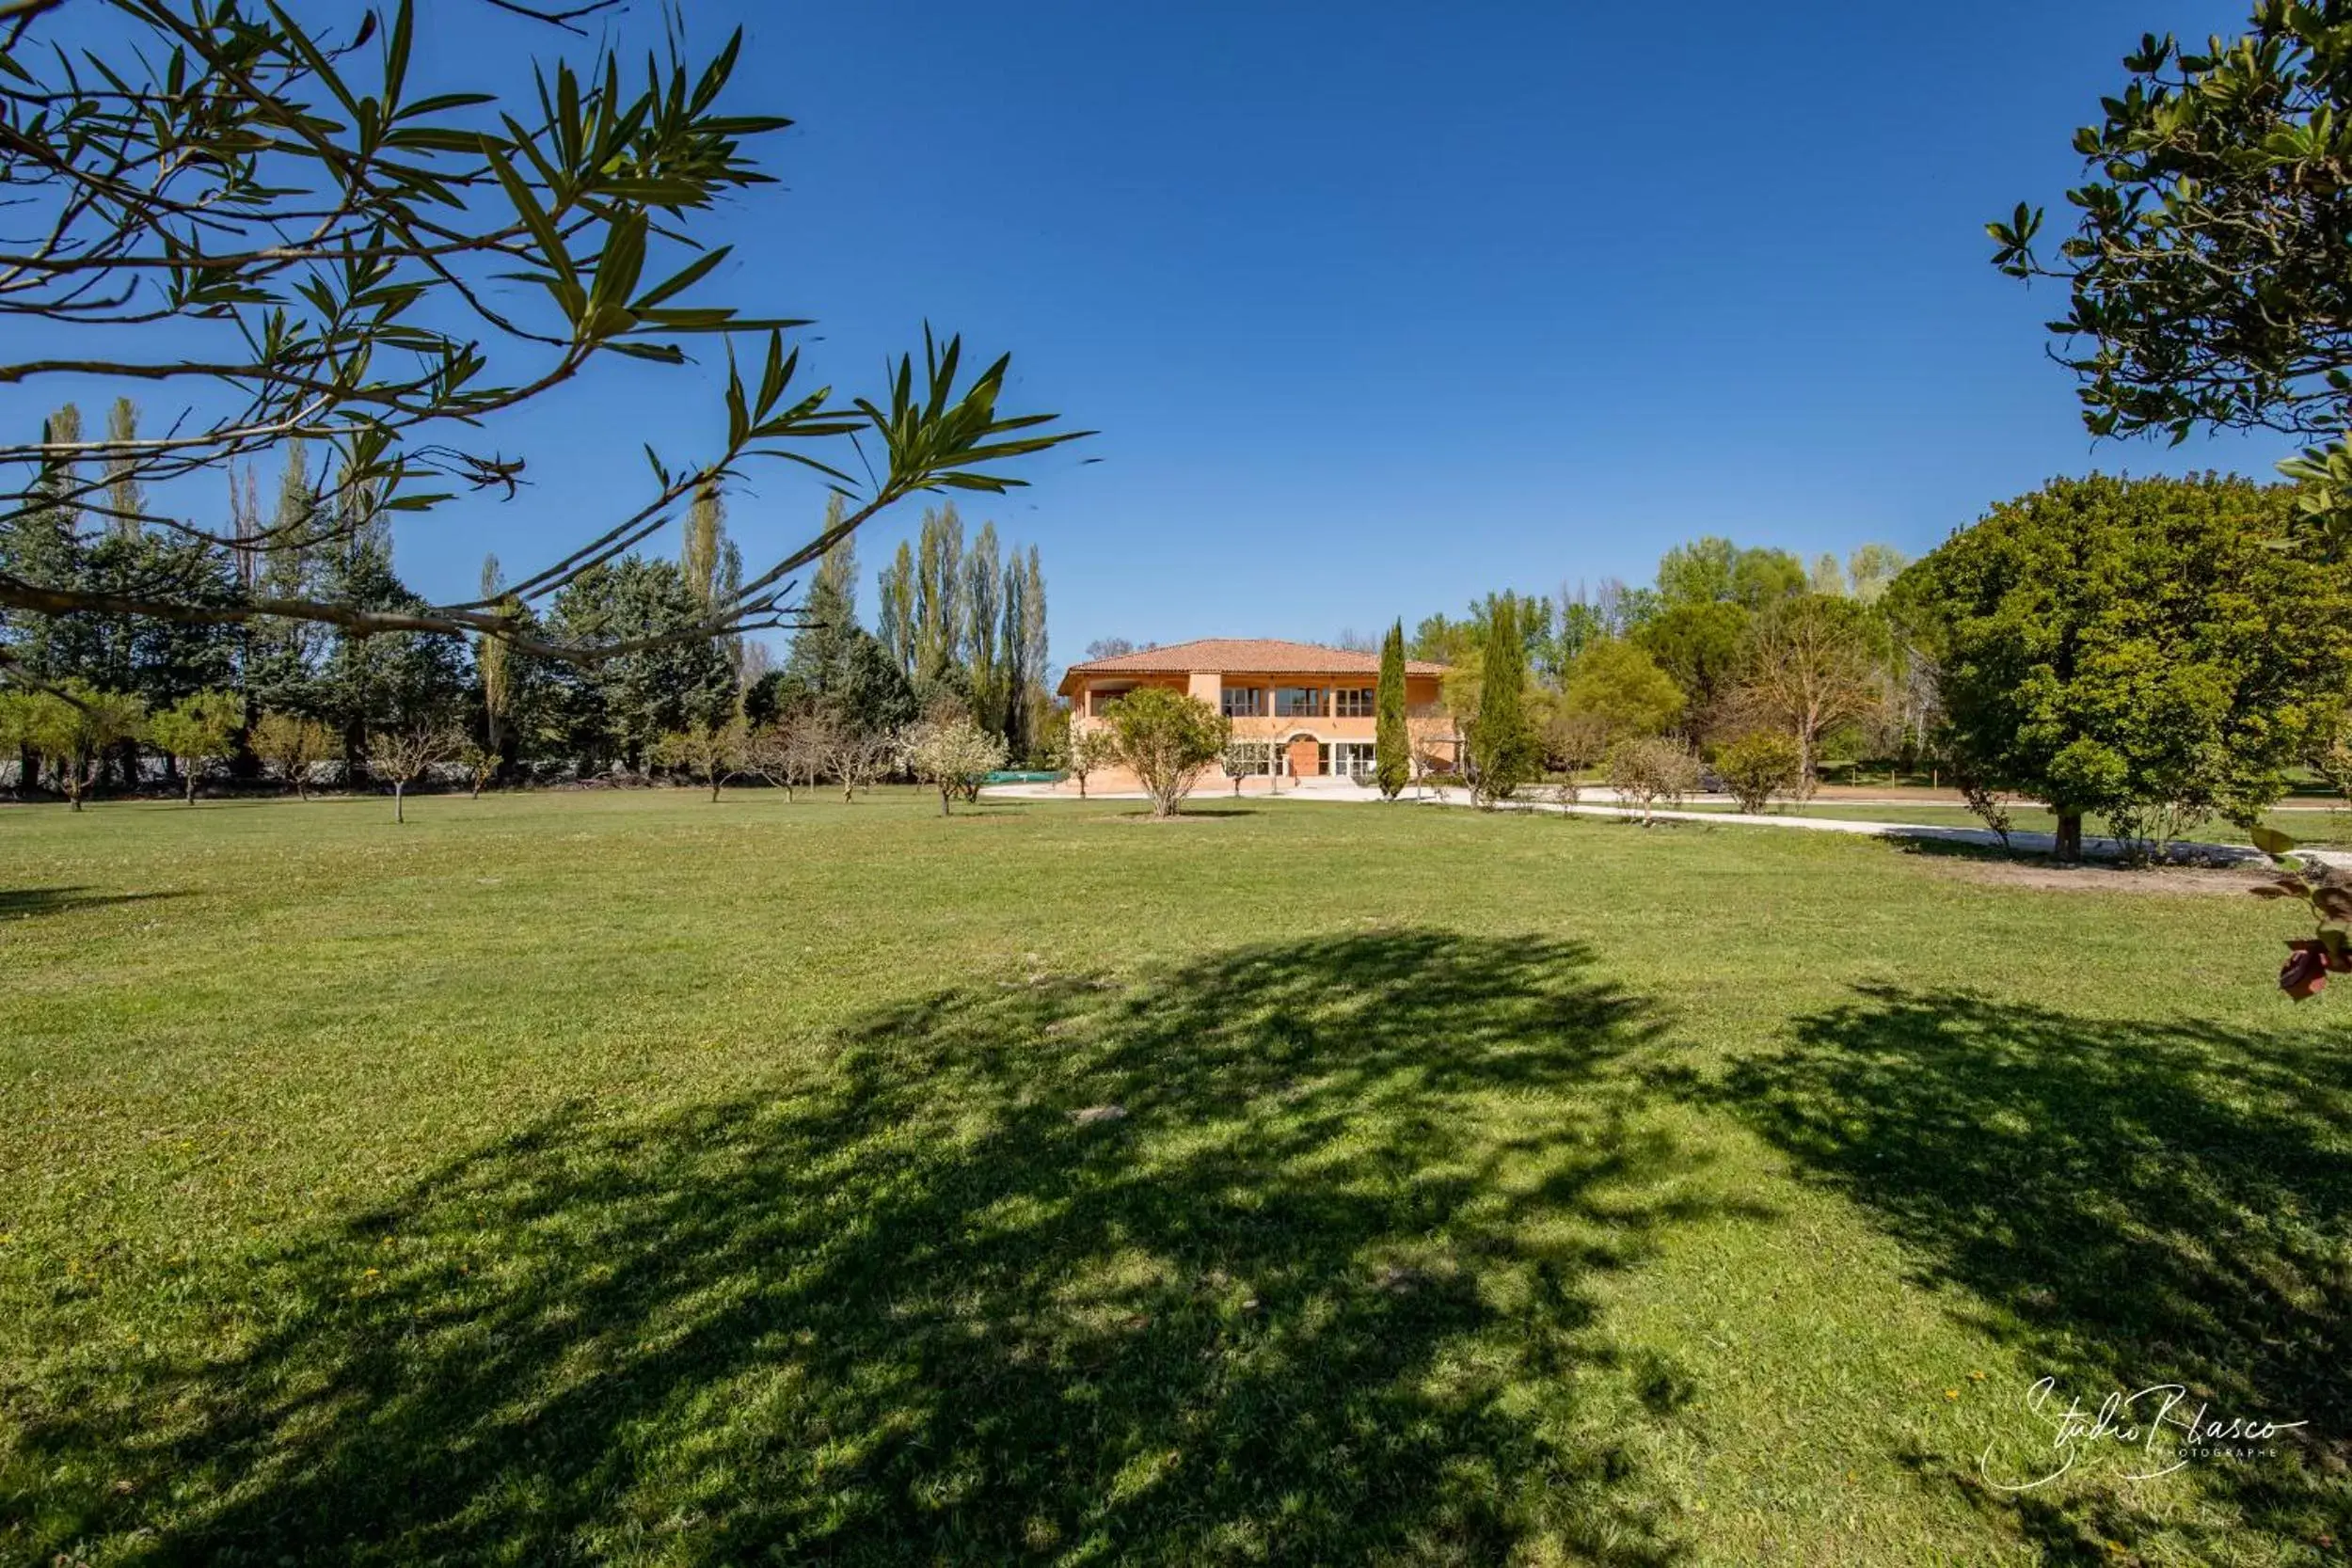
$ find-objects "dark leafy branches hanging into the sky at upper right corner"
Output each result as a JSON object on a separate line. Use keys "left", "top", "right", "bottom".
{"left": 1988, "top": 0, "right": 2352, "bottom": 555}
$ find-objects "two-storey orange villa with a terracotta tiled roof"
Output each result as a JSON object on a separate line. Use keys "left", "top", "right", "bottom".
{"left": 1061, "top": 637, "right": 1458, "bottom": 787}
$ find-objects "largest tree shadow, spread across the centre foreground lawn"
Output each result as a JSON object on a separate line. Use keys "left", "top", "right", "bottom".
{"left": 26, "top": 931, "right": 1712, "bottom": 1563}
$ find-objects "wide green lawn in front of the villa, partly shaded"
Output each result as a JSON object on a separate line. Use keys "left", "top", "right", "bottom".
{"left": 0, "top": 792, "right": 2352, "bottom": 1563}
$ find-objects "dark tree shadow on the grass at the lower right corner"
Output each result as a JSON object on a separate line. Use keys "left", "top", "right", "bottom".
{"left": 1710, "top": 988, "right": 2352, "bottom": 1561}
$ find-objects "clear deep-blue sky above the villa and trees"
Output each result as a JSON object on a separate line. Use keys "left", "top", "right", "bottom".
{"left": 8, "top": 0, "right": 2284, "bottom": 660}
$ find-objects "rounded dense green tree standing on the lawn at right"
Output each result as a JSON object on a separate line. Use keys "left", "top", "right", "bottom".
{"left": 1894, "top": 477, "right": 2352, "bottom": 856}
